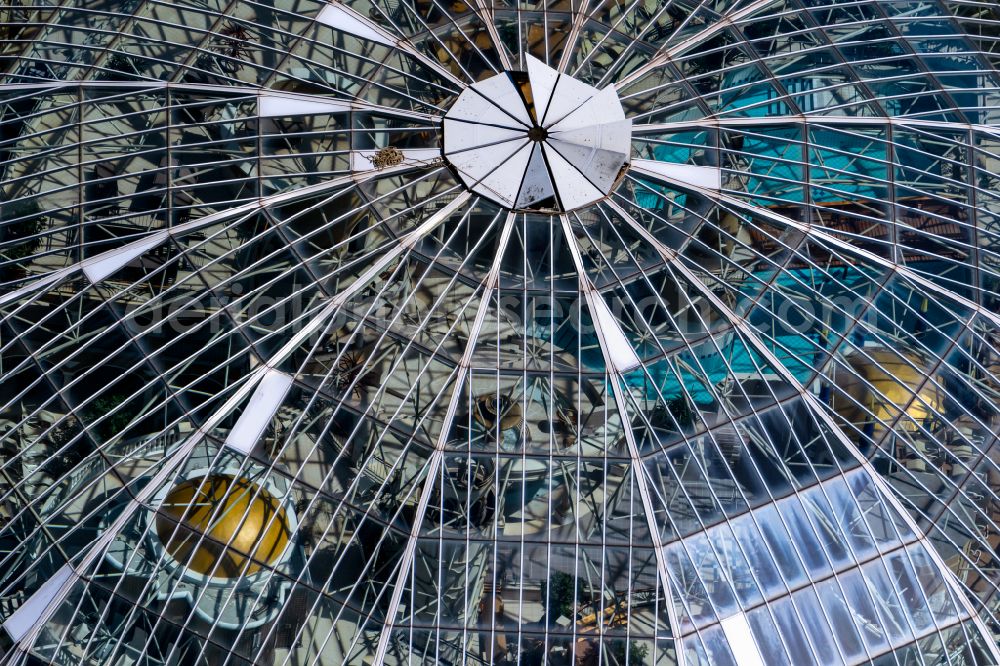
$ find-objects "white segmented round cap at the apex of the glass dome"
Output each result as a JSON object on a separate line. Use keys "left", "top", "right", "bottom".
{"left": 444, "top": 56, "right": 632, "bottom": 212}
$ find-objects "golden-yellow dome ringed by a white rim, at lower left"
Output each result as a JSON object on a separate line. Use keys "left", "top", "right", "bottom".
{"left": 156, "top": 474, "right": 291, "bottom": 578}
